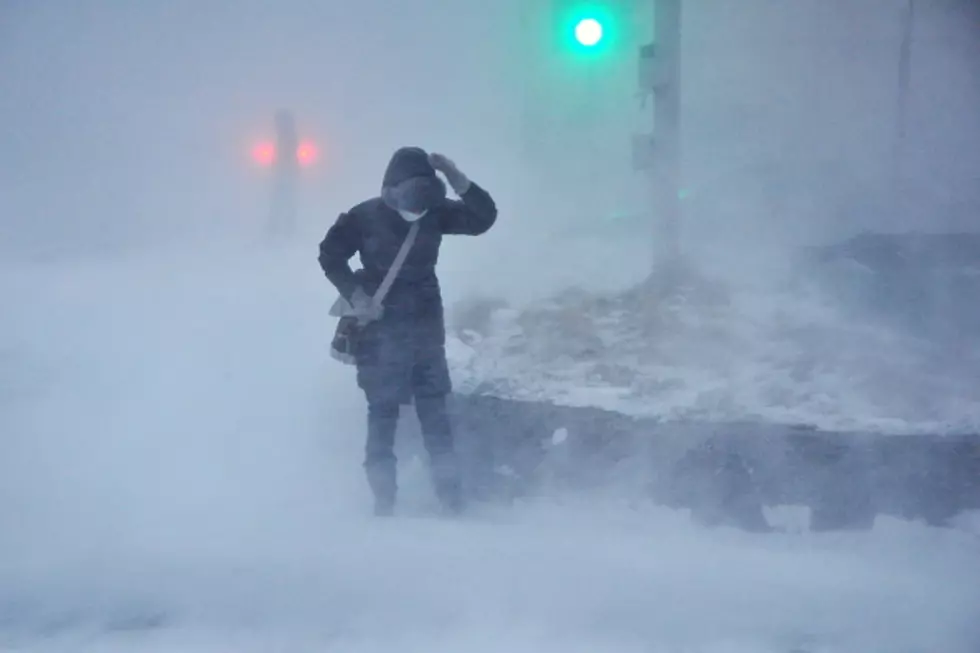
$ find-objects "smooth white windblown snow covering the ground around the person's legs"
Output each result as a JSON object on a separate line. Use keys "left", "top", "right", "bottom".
{"left": 0, "top": 246, "right": 980, "bottom": 653}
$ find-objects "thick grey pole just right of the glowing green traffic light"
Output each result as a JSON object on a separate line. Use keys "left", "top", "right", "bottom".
{"left": 633, "top": 0, "right": 682, "bottom": 284}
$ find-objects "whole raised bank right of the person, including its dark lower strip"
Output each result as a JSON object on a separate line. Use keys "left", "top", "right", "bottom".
{"left": 450, "top": 234, "right": 980, "bottom": 529}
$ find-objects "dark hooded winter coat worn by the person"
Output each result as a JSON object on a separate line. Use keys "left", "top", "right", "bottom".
{"left": 319, "top": 151, "right": 497, "bottom": 404}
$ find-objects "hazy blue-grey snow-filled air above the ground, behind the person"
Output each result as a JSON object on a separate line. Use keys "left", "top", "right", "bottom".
{"left": 0, "top": 0, "right": 980, "bottom": 262}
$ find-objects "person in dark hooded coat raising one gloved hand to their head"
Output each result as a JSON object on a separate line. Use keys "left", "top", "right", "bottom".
{"left": 319, "top": 147, "right": 497, "bottom": 515}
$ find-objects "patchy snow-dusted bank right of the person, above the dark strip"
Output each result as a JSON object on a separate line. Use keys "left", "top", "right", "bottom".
{"left": 450, "top": 238, "right": 980, "bottom": 434}
